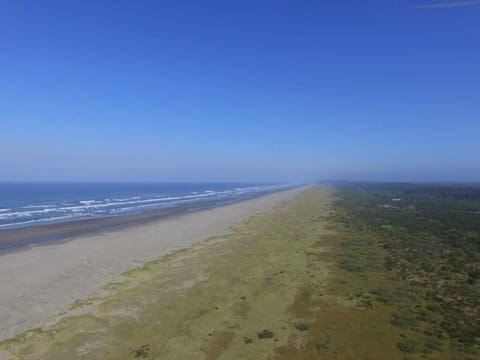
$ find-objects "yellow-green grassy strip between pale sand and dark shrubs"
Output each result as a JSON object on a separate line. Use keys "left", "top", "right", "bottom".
{"left": 0, "top": 187, "right": 478, "bottom": 360}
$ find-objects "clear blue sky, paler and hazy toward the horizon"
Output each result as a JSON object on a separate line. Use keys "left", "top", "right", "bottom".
{"left": 0, "top": 0, "right": 480, "bottom": 181}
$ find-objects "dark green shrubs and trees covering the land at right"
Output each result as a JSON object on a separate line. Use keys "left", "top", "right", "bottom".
{"left": 332, "top": 184, "right": 480, "bottom": 353}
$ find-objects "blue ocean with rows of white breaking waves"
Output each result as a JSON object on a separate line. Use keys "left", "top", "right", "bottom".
{"left": 0, "top": 183, "right": 289, "bottom": 230}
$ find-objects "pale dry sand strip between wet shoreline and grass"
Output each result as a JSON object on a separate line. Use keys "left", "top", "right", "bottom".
{"left": 0, "top": 188, "right": 304, "bottom": 341}
